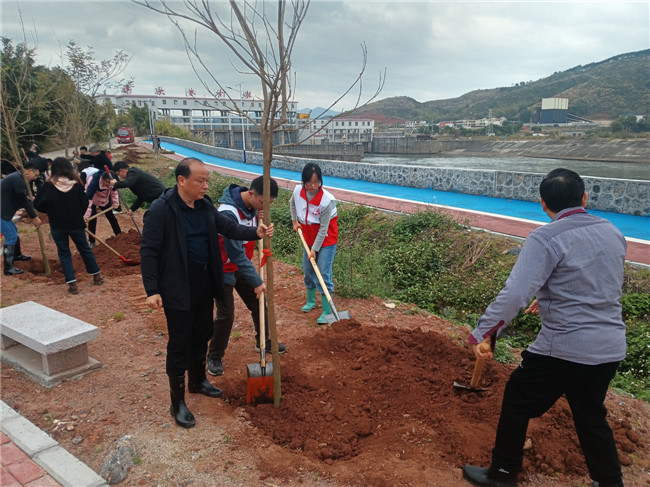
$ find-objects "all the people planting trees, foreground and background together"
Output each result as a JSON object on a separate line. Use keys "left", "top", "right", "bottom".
{"left": 2, "top": 142, "right": 626, "bottom": 487}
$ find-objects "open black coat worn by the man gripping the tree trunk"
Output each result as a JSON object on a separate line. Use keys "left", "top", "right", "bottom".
{"left": 140, "top": 186, "right": 259, "bottom": 311}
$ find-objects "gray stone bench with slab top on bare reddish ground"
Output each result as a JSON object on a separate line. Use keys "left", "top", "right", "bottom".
{"left": 0, "top": 301, "right": 102, "bottom": 387}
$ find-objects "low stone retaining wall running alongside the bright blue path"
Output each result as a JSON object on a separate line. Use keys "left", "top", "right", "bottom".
{"left": 160, "top": 136, "right": 650, "bottom": 216}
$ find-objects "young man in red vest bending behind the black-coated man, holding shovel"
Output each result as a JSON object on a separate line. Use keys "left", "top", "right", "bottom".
{"left": 208, "top": 176, "right": 287, "bottom": 375}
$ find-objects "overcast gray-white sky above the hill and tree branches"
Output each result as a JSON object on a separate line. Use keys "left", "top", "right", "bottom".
{"left": 1, "top": 0, "right": 650, "bottom": 110}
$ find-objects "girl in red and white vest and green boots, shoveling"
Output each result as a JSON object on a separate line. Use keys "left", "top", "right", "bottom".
{"left": 290, "top": 162, "right": 339, "bottom": 324}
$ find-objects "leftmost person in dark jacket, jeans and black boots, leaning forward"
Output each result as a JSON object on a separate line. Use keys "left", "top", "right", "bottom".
{"left": 0, "top": 162, "right": 41, "bottom": 276}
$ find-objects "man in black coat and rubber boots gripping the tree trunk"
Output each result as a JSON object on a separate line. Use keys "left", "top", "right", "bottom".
{"left": 140, "top": 158, "right": 273, "bottom": 428}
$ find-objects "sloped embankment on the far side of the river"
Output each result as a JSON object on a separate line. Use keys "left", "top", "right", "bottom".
{"left": 372, "top": 138, "right": 650, "bottom": 164}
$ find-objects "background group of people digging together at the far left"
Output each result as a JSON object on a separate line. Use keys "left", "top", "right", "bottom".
{"left": 0, "top": 144, "right": 139, "bottom": 295}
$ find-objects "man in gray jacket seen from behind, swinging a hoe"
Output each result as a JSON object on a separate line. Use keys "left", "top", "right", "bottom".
{"left": 463, "top": 169, "right": 626, "bottom": 487}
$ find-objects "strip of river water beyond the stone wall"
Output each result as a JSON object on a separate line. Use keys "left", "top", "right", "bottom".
{"left": 361, "top": 154, "right": 650, "bottom": 180}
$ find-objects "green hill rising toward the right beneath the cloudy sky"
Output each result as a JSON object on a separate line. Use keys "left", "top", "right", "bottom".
{"left": 346, "top": 49, "right": 650, "bottom": 125}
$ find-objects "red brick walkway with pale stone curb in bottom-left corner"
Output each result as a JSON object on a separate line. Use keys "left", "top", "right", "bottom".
{"left": 0, "top": 401, "right": 108, "bottom": 487}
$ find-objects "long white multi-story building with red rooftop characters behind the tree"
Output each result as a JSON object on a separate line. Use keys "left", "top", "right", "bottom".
{"left": 97, "top": 93, "right": 298, "bottom": 150}
